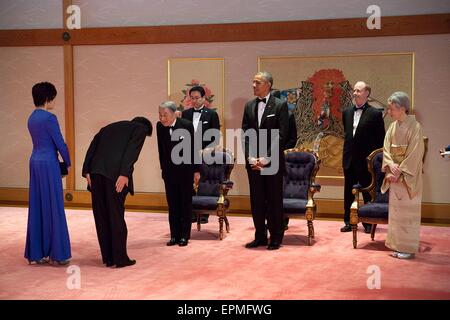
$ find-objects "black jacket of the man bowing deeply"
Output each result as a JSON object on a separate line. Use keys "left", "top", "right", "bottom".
{"left": 82, "top": 121, "right": 147, "bottom": 195}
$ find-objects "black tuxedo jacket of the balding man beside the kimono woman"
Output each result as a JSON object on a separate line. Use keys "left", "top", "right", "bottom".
{"left": 342, "top": 102, "right": 385, "bottom": 170}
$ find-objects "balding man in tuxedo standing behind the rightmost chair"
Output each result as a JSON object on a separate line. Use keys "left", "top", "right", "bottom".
{"left": 341, "top": 81, "right": 385, "bottom": 233}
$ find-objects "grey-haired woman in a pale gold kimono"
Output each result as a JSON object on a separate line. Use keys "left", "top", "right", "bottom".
{"left": 381, "top": 92, "right": 424, "bottom": 259}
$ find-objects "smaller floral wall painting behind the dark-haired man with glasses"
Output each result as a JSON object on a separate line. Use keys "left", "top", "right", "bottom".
{"left": 168, "top": 58, "right": 225, "bottom": 128}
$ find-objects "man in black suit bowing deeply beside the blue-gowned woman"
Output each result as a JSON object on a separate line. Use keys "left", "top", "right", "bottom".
{"left": 82, "top": 117, "right": 153, "bottom": 268}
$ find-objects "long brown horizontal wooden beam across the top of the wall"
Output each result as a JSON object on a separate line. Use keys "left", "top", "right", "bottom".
{"left": 0, "top": 14, "right": 450, "bottom": 46}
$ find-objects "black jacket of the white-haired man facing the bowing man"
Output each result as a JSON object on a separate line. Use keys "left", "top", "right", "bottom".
{"left": 156, "top": 118, "right": 200, "bottom": 184}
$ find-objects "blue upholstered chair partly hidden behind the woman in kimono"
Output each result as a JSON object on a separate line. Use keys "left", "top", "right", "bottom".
{"left": 350, "top": 137, "right": 428, "bottom": 249}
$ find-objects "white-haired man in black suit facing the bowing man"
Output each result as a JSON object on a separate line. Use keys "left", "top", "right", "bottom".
{"left": 156, "top": 101, "right": 200, "bottom": 247}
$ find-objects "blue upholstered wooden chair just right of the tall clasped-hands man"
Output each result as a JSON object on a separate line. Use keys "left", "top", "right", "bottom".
{"left": 283, "top": 148, "right": 320, "bottom": 245}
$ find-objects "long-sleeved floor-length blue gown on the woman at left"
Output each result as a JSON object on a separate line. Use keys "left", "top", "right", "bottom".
{"left": 25, "top": 109, "right": 71, "bottom": 261}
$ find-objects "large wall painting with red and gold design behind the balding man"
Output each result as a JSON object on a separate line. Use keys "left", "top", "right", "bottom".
{"left": 258, "top": 53, "right": 414, "bottom": 179}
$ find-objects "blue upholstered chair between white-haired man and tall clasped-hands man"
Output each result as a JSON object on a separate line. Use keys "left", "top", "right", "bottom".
{"left": 192, "top": 146, "right": 234, "bottom": 240}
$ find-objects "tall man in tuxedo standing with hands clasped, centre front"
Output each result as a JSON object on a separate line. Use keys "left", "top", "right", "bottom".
{"left": 242, "top": 72, "right": 289, "bottom": 250}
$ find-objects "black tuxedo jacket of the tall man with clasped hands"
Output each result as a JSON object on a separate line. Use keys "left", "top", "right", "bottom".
{"left": 242, "top": 95, "right": 289, "bottom": 173}
